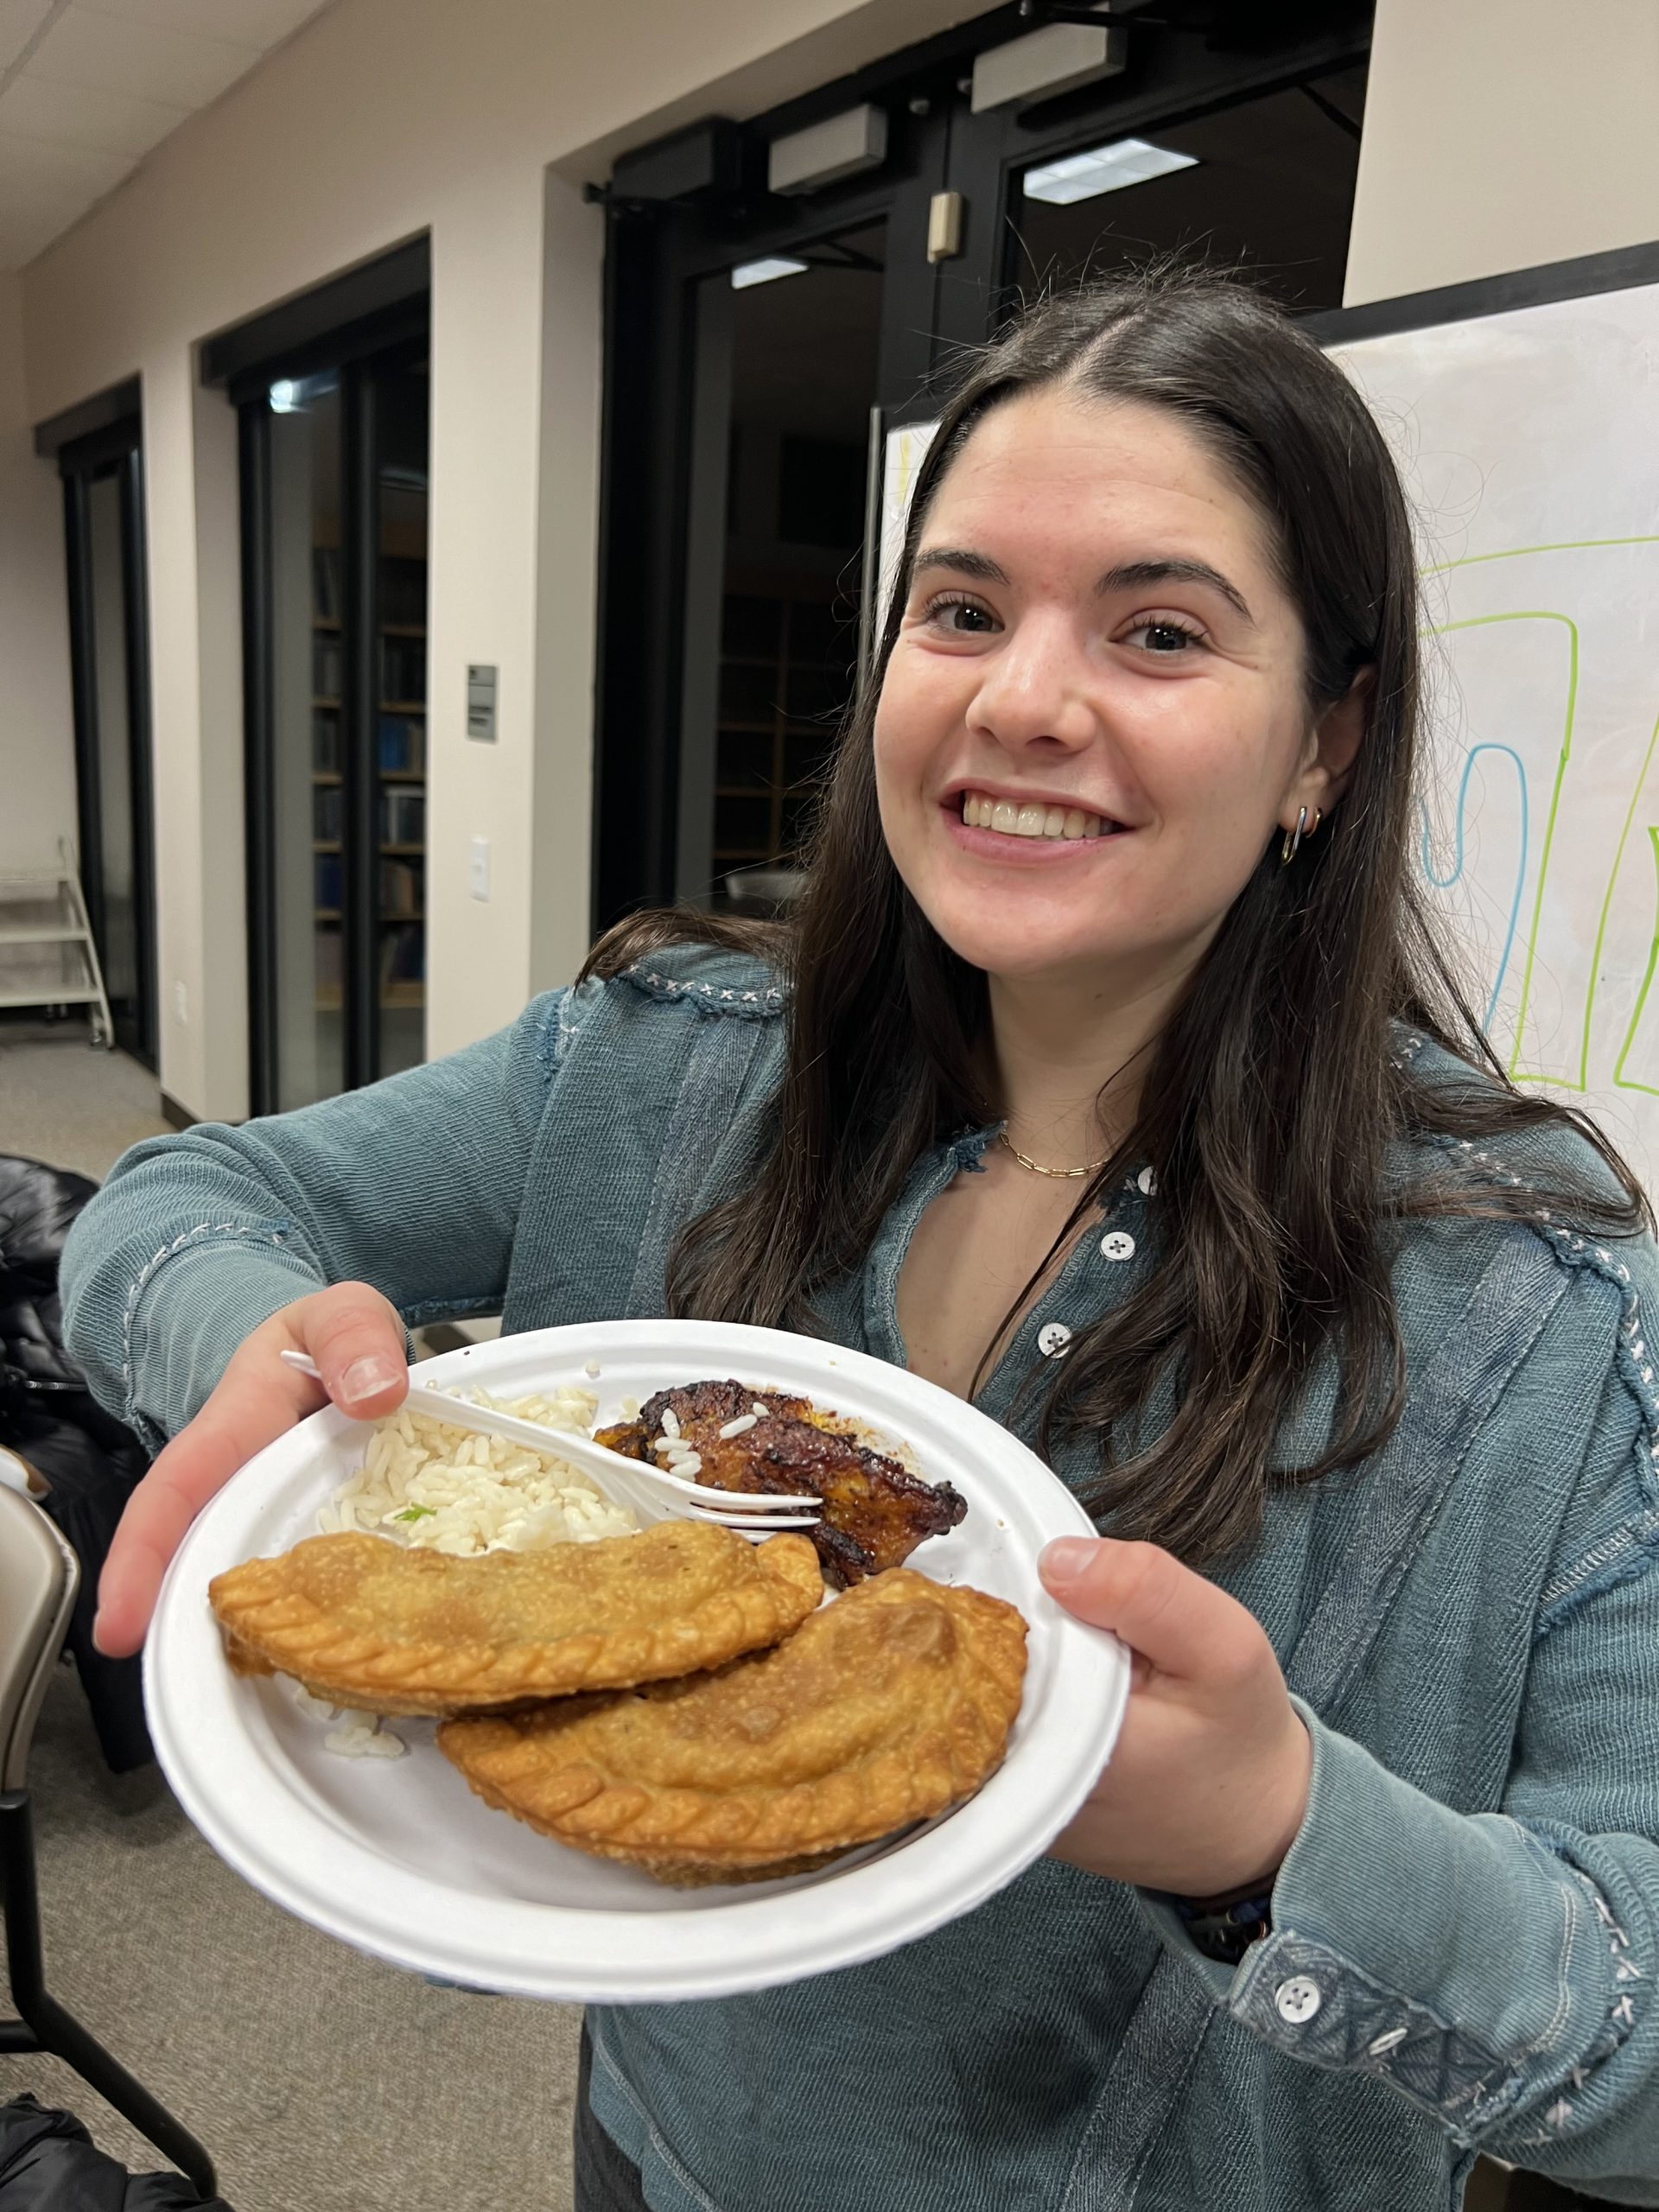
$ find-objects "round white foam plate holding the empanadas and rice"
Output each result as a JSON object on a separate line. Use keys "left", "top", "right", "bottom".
{"left": 143, "top": 1320, "right": 1128, "bottom": 2004}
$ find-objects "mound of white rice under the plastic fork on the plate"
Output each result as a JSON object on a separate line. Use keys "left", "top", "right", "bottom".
{"left": 316, "top": 1385, "right": 639, "bottom": 1557}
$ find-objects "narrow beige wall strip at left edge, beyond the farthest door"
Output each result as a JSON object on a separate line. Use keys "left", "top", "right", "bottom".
{"left": 0, "top": 276, "right": 75, "bottom": 874}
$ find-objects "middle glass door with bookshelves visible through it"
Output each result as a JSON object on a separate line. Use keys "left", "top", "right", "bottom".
{"left": 241, "top": 343, "right": 427, "bottom": 1113}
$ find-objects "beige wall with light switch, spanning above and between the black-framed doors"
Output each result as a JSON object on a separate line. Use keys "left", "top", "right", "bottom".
{"left": 13, "top": 0, "right": 980, "bottom": 1115}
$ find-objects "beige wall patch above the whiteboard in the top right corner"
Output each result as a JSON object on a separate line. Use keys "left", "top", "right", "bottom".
{"left": 1344, "top": 0, "right": 1659, "bottom": 305}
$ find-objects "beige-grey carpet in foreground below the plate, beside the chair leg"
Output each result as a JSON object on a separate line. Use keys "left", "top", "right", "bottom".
{"left": 0, "top": 1668, "right": 580, "bottom": 2212}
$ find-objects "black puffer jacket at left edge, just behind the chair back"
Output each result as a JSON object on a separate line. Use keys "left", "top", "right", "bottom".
{"left": 0, "top": 1154, "right": 150, "bottom": 1774}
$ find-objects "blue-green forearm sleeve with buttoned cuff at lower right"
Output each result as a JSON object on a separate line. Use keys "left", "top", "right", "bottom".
{"left": 1153, "top": 1327, "right": 1659, "bottom": 2205}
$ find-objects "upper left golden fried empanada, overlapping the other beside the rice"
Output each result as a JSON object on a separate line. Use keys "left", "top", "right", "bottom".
{"left": 208, "top": 1520, "right": 823, "bottom": 1714}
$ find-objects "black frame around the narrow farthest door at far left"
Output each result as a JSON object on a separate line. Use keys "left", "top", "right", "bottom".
{"left": 58, "top": 414, "right": 159, "bottom": 1073}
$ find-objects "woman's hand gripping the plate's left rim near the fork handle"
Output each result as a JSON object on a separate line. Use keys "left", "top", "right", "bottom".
{"left": 93, "top": 1283, "right": 410, "bottom": 1659}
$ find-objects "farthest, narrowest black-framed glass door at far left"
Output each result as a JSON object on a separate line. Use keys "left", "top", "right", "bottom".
{"left": 58, "top": 418, "right": 157, "bottom": 1068}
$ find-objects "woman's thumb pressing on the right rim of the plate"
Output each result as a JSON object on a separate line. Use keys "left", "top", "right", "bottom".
{"left": 1038, "top": 1535, "right": 1259, "bottom": 1679}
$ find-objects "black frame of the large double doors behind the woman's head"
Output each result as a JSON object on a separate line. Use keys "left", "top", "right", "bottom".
{"left": 593, "top": 0, "right": 1371, "bottom": 929}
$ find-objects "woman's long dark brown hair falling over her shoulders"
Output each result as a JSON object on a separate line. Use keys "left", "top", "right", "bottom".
{"left": 588, "top": 268, "right": 1650, "bottom": 1564}
